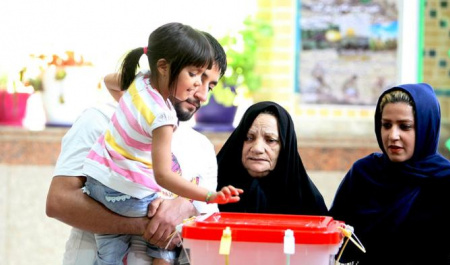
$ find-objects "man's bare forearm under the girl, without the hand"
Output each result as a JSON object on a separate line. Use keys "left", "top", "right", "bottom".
{"left": 46, "top": 176, "right": 149, "bottom": 235}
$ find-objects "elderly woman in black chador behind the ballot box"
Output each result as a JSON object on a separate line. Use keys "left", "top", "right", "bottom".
{"left": 217, "top": 102, "right": 328, "bottom": 215}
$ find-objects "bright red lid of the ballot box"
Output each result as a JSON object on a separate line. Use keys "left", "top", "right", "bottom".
{"left": 182, "top": 212, "right": 344, "bottom": 244}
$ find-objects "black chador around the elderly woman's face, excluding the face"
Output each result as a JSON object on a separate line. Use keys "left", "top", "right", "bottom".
{"left": 217, "top": 101, "right": 328, "bottom": 215}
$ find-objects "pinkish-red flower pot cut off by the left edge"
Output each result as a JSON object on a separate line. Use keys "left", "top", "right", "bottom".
{"left": 0, "top": 90, "right": 31, "bottom": 127}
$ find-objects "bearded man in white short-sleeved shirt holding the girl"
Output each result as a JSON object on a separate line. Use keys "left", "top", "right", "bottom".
{"left": 46, "top": 33, "right": 227, "bottom": 265}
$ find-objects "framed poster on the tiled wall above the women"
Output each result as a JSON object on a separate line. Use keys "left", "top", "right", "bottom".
{"left": 297, "top": 0, "right": 398, "bottom": 105}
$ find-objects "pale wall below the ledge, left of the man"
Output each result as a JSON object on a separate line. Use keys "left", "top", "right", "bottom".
{"left": 0, "top": 164, "right": 70, "bottom": 265}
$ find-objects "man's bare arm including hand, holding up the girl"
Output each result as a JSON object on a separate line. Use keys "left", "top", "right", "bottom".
{"left": 46, "top": 172, "right": 198, "bottom": 248}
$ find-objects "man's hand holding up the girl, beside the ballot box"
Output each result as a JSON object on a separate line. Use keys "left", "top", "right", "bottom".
{"left": 143, "top": 197, "right": 198, "bottom": 249}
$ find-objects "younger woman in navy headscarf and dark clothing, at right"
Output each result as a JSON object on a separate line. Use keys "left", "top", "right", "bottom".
{"left": 330, "top": 83, "right": 450, "bottom": 265}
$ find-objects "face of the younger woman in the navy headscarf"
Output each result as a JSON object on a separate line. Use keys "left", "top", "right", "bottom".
{"left": 381, "top": 102, "right": 416, "bottom": 162}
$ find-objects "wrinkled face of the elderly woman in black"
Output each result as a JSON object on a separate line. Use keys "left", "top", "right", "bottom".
{"left": 242, "top": 113, "right": 281, "bottom": 178}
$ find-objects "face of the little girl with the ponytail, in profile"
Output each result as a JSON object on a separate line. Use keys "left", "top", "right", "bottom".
{"left": 175, "top": 66, "right": 207, "bottom": 101}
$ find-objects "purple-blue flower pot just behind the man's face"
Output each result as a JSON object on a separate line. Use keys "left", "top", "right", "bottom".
{"left": 194, "top": 96, "right": 237, "bottom": 132}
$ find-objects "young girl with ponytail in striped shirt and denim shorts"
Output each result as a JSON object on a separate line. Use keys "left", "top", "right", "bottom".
{"left": 84, "top": 23, "right": 242, "bottom": 264}
